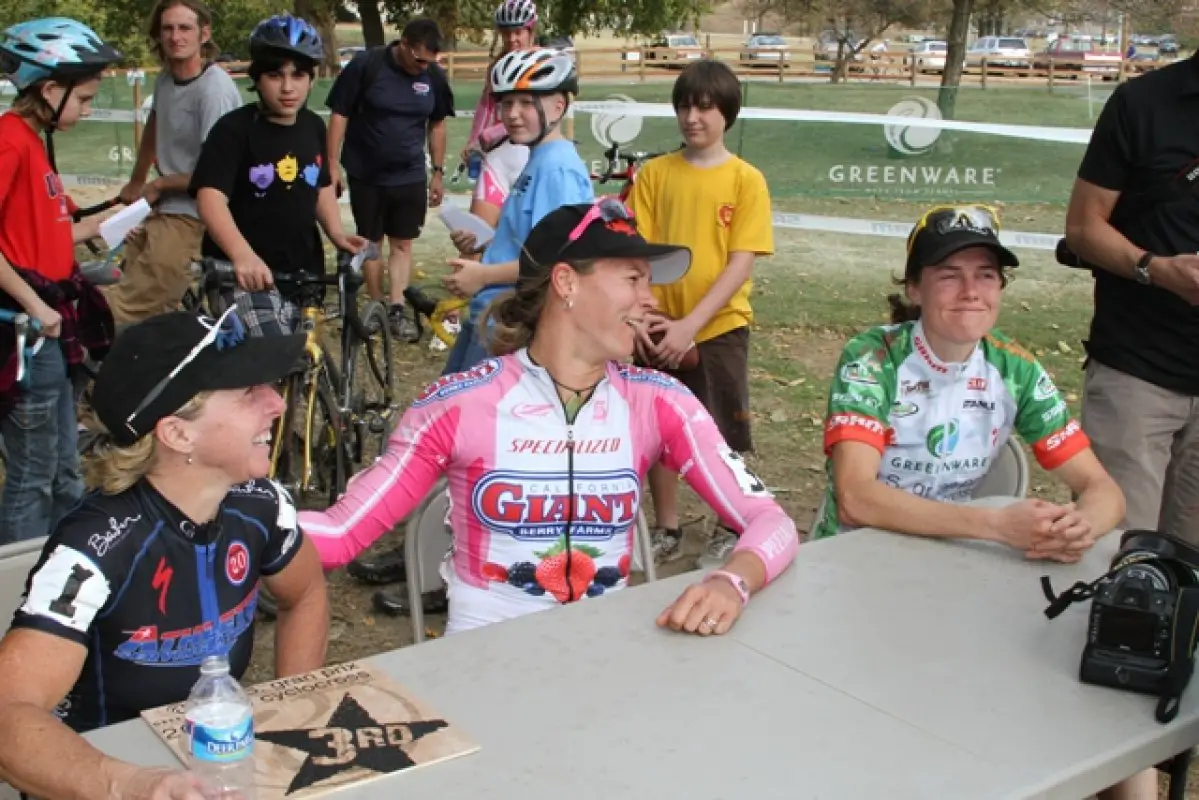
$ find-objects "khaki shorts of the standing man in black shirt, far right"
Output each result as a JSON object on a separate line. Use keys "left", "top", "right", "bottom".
{"left": 1083, "top": 359, "right": 1199, "bottom": 546}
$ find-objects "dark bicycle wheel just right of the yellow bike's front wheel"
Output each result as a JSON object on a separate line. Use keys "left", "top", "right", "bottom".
{"left": 341, "top": 300, "right": 397, "bottom": 464}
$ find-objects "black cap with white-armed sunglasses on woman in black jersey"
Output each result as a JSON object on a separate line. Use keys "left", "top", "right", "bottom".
{"left": 91, "top": 308, "right": 306, "bottom": 446}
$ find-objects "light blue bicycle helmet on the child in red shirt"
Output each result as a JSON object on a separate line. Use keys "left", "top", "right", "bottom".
{"left": 0, "top": 17, "right": 121, "bottom": 91}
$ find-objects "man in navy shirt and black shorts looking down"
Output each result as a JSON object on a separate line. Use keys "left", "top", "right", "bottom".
{"left": 327, "top": 19, "right": 453, "bottom": 342}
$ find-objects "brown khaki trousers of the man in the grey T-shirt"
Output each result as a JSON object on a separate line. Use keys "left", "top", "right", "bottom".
{"left": 103, "top": 213, "right": 204, "bottom": 326}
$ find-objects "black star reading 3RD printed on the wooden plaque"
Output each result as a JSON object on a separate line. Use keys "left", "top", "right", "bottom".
{"left": 254, "top": 692, "right": 447, "bottom": 794}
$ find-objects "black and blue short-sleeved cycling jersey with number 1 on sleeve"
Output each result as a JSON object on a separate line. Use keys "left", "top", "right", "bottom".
{"left": 13, "top": 480, "right": 302, "bottom": 732}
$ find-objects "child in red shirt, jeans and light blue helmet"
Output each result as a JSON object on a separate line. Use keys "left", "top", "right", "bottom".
{"left": 0, "top": 17, "right": 121, "bottom": 545}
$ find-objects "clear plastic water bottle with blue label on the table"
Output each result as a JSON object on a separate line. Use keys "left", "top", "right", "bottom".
{"left": 183, "top": 656, "right": 255, "bottom": 800}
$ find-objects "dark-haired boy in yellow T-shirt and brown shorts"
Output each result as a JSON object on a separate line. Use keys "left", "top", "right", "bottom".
{"left": 629, "top": 60, "right": 775, "bottom": 565}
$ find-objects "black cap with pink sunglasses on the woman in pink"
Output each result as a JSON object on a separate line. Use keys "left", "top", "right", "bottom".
{"left": 520, "top": 197, "right": 691, "bottom": 284}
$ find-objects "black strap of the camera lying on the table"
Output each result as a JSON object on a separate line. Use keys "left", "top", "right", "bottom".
{"left": 1041, "top": 552, "right": 1199, "bottom": 723}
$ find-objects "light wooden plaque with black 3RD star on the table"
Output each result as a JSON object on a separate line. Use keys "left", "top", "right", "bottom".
{"left": 141, "top": 661, "right": 478, "bottom": 800}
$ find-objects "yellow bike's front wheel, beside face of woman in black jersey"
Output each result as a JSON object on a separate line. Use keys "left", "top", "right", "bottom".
{"left": 276, "top": 369, "right": 348, "bottom": 507}
